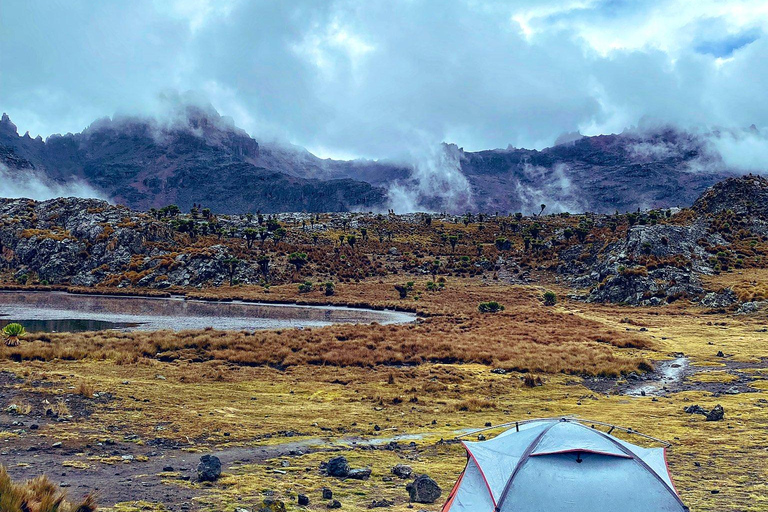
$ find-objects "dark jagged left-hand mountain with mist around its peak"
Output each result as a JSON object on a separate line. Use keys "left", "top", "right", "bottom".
{"left": 0, "top": 107, "right": 386, "bottom": 212}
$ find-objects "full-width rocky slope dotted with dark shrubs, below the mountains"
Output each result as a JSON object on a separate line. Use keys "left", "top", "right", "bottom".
{"left": 0, "top": 176, "right": 768, "bottom": 307}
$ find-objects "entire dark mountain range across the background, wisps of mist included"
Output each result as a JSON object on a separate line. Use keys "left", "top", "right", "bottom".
{"left": 0, "top": 106, "right": 737, "bottom": 214}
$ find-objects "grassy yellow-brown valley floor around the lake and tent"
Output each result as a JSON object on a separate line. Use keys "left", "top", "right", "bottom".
{"left": 0, "top": 279, "right": 768, "bottom": 512}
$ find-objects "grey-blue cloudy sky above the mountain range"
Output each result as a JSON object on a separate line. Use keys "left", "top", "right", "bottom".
{"left": 0, "top": 0, "right": 768, "bottom": 157}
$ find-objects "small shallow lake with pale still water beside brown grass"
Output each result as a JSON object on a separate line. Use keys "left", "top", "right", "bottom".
{"left": 0, "top": 291, "right": 416, "bottom": 332}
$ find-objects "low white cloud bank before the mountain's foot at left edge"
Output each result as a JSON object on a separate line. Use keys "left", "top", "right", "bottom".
{"left": 0, "top": 163, "right": 104, "bottom": 201}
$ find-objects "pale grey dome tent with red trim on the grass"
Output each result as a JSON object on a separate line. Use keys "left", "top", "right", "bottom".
{"left": 441, "top": 418, "right": 688, "bottom": 512}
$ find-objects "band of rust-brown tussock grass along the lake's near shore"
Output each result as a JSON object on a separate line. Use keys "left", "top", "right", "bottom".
{"left": 0, "top": 283, "right": 652, "bottom": 376}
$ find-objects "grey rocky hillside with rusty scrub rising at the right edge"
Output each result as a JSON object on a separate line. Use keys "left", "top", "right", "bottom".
{"left": 559, "top": 175, "right": 768, "bottom": 307}
